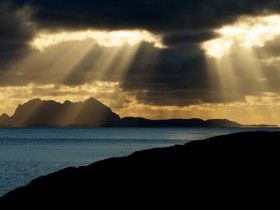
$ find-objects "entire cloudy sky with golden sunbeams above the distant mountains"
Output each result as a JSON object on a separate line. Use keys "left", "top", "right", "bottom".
{"left": 0, "top": 0, "right": 280, "bottom": 125}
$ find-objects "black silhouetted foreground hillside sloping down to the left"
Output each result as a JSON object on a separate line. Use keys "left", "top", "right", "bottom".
{"left": 0, "top": 132, "right": 280, "bottom": 210}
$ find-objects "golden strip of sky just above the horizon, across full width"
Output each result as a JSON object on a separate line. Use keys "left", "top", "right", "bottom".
{"left": 0, "top": 81, "right": 280, "bottom": 125}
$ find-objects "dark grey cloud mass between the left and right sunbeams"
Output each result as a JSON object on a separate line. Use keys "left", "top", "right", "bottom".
{"left": 122, "top": 44, "right": 231, "bottom": 106}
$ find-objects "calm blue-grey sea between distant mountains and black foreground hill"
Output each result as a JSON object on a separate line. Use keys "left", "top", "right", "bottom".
{"left": 0, "top": 128, "right": 279, "bottom": 196}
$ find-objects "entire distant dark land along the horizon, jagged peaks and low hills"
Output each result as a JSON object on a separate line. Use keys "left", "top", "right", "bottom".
{"left": 0, "top": 98, "right": 242, "bottom": 127}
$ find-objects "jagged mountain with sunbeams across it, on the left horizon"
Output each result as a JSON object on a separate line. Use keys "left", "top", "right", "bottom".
{"left": 0, "top": 98, "right": 120, "bottom": 127}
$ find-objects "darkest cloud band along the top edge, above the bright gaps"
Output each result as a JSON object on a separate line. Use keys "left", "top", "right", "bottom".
{"left": 8, "top": 0, "right": 278, "bottom": 33}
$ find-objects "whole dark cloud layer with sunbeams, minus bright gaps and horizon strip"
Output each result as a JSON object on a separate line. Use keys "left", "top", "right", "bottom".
{"left": 0, "top": 0, "right": 280, "bottom": 110}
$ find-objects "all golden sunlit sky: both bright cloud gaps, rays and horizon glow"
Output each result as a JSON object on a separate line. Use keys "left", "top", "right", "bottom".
{"left": 0, "top": 18, "right": 280, "bottom": 124}
